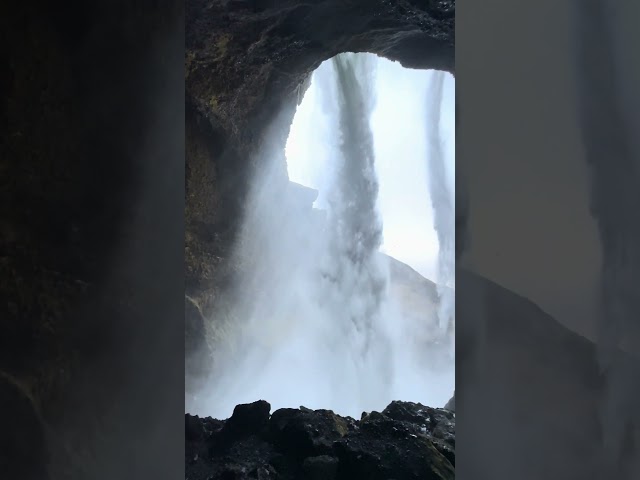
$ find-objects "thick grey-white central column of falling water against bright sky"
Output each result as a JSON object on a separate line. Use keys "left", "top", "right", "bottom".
{"left": 325, "top": 55, "right": 387, "bottom": 368}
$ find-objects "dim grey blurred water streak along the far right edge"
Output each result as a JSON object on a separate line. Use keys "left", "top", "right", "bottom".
{"left": 573, "top": 0, "right": 640, "bottom": 478}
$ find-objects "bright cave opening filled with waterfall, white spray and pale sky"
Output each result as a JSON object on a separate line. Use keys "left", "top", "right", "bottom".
{"left": 194, "top": 54, "right": 455, "bottom": 418}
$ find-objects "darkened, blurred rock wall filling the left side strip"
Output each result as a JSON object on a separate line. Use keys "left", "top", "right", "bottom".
{"left": 0, "top": 0, "right": 184, "bottom": 479}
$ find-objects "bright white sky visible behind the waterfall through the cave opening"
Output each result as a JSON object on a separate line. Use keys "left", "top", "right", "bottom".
{"left": 286, "top": 58, "right": 455, "bottom": 280}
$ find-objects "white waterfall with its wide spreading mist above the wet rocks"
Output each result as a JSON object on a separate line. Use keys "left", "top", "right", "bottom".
{"left": 194, "top": 54, "right": 454, "bottom": 418}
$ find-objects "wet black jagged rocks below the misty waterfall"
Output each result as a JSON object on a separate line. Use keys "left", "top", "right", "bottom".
{"left": 185, "top": 400, "right": 455, "bottom": 480}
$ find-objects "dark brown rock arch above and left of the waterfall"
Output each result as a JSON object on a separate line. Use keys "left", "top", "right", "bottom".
{"left": 185, "top": 0, "right": 455, "bottom": 372}
